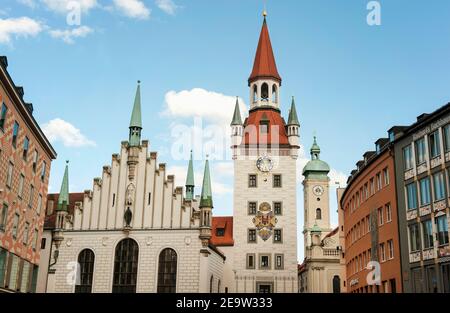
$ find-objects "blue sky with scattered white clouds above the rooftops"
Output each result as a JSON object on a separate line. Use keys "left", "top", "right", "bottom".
{"left": 0, "top": 0, "right": 450, "bottom": 258}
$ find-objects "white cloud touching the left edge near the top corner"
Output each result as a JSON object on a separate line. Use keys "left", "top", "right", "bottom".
{"left": 0, "top": 17, "right": 43, "bottom": 43}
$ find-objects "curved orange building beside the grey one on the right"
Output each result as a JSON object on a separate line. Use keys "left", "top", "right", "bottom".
{"left": 339, "top": 138, "right": 402, "bottom": 293}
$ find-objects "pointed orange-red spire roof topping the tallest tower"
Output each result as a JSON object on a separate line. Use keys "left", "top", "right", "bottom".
{"left": 248, "top": 17, "right": 281, "bottom": 85}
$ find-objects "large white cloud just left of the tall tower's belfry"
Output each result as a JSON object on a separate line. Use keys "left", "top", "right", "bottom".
{"left": 164, "top": 88, "right": 247, "bottom": 126}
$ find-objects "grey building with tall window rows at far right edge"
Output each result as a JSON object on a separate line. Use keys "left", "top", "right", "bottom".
{"left": 390, "top": 104, "right": 450, "bottom": 293}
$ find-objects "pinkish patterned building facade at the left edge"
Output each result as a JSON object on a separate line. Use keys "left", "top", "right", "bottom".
{"left": 0, "top": 56, "right": 56, "bottom": 292}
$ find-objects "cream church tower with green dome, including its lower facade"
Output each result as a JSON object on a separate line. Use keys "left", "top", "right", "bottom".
{"left": 299, "top": 137, "right": 344, "bottom": 293}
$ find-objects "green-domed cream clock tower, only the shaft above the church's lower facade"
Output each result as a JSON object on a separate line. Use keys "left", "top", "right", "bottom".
{"left": 303, "top": 137, "right": 331, "bottom": 249}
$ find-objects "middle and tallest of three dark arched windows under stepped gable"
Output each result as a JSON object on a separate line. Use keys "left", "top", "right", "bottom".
{"left": 112, "top": 238, "right": 139, "bottom": 293}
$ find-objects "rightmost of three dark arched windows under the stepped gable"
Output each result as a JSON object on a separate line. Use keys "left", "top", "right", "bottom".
{"left": 158, "top": 248, "right": 177, "bottom": 293}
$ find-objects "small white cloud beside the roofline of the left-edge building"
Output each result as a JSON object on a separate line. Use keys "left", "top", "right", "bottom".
{"left": 42, "top": 118, "right": 96, "bottom": 148}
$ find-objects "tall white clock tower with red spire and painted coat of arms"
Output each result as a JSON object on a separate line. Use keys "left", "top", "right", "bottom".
{"left": 230, "top": 14, "right": 300, "bottom": 293}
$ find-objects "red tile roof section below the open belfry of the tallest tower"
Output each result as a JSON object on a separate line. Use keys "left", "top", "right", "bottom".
{"left": 243, "top": 109, "right": 289, "bottom": 145}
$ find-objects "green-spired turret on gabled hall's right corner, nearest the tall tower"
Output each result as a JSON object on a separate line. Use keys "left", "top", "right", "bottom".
{"left": 199, "top": 160, "right": 213, "bottom": 248}
